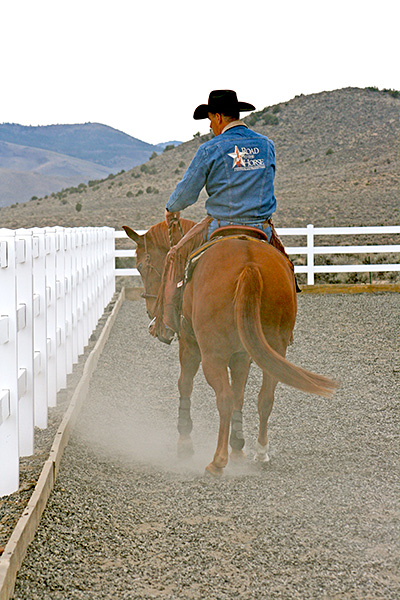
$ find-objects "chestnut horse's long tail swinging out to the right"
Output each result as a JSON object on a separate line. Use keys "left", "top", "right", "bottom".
{"left": 234, "top": 265, "right": 337, "bottom": 397}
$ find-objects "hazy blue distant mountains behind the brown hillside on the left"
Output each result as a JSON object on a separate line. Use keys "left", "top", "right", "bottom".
{"left": 0, "top": 123, "right": 180, "bottom": 206}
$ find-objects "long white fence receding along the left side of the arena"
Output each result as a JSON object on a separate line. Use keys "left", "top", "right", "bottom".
{"left": 0, "top": 227, "right": 115, "bottom": 496}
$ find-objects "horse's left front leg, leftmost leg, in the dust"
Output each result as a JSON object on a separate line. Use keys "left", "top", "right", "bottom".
{"left": 178, "top": 334, "right": 201, "bottom": 458}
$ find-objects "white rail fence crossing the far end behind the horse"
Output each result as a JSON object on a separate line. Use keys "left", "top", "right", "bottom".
{"left": 115, "top": 225, "right": 400, "bottom": 285}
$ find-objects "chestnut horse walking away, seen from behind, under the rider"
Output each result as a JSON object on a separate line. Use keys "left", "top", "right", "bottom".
{"left": 124, "top": 219, "right": 337, "bottom": 475}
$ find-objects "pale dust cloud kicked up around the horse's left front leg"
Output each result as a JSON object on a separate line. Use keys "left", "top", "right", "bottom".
{"left": 75, "top": 382, "right": 223, "bottom": 475}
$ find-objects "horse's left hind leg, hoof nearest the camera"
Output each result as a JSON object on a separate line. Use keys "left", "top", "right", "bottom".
{"left": 203, "top": 357, "right": 234, "bottom": 476}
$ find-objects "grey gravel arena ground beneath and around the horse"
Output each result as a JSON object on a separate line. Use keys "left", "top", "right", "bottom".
{"left": 10, "top": 294, "right": 400, "bottom": 600}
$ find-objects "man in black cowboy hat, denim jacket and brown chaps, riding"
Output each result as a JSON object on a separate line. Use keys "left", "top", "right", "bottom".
{"left": 149, "top": 90, "right": 282, "bottom": 344}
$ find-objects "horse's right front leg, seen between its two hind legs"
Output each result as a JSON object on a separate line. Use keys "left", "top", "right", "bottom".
{"left": 229, "top": 352, "right": 250, "bottom": 460}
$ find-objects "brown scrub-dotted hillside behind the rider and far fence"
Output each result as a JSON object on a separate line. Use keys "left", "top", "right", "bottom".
{"left": 0, "top": 88, "right": 400, "bottom": 229}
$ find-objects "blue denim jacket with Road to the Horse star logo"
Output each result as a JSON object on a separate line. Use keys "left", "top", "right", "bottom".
{"left": 167, "top": 125, "right": 276, "bottom": 225}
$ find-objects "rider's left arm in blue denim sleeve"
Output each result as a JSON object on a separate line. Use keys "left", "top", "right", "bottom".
{"left": 166, "top": 146, "right": 208, "bottom": 212}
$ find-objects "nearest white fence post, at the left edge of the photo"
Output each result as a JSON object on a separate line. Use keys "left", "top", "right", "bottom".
{"left": 0, "top": 229, "right": 19, "bottom": 496}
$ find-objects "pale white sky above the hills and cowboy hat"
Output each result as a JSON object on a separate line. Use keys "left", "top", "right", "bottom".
{"left": 0, "top": 0, "right": 400, "bottom": 144}
